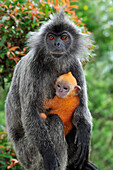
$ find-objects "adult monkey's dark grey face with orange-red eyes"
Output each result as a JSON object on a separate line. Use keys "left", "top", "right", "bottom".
{"left": 46, "top": 32, "right": 71, "bottom": 57}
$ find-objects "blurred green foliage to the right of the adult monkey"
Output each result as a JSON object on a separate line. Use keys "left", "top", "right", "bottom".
{"left": 76, "top": 0, "right": 113, "bottom": 170}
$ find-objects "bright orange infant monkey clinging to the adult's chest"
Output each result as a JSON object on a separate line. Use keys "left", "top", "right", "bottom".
{"left": 41, "top": 72, "right": 81, "bottom": 136}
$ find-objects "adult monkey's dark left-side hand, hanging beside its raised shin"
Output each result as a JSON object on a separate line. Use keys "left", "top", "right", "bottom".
{"left": 43, "top": 148, "right": 59, "bottom": 170}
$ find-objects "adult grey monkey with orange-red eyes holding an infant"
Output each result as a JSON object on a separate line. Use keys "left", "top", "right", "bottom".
{"left": 5, "top": 12, "right": 96, "bottom": 170}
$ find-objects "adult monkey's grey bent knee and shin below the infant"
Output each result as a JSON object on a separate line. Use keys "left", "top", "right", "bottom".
{"left": 46, "top": 114, "right": 67, "bottom": 170}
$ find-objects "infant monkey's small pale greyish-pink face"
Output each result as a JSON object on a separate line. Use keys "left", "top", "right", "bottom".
{"left": 56, "top": 82, "right": 70, "bottom": 98}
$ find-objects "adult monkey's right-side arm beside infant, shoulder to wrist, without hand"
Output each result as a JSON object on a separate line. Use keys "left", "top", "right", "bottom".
{"left": 71, "top": 59, "right": 92, "bottom": 127}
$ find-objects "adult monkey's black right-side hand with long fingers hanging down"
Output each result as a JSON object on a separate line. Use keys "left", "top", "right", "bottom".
{"left": 73, "top": 118, "right": 91, "bottom": 170}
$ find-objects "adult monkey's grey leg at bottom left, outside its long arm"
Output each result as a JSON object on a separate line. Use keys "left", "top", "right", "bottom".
{"left": 14, "top": 136, "right": 44, "bottom": 170}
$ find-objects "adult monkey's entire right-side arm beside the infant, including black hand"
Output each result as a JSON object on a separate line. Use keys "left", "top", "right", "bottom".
{"left": 71, "top": 60, "right": 92, "bottom": 169}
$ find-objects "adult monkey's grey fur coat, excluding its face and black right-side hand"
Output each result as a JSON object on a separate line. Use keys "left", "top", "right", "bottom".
{"left": 5, "top": 13, "right": 92, "bottom": 170}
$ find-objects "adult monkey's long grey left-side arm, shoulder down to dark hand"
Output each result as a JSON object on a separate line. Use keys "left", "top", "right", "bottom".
{"left": 19, "top": 58, "right": 58, "bottom": 170}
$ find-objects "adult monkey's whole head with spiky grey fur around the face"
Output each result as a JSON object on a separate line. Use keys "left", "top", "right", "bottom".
{"left": 27, "top": 10, "right": 92, "bottom": 59}
